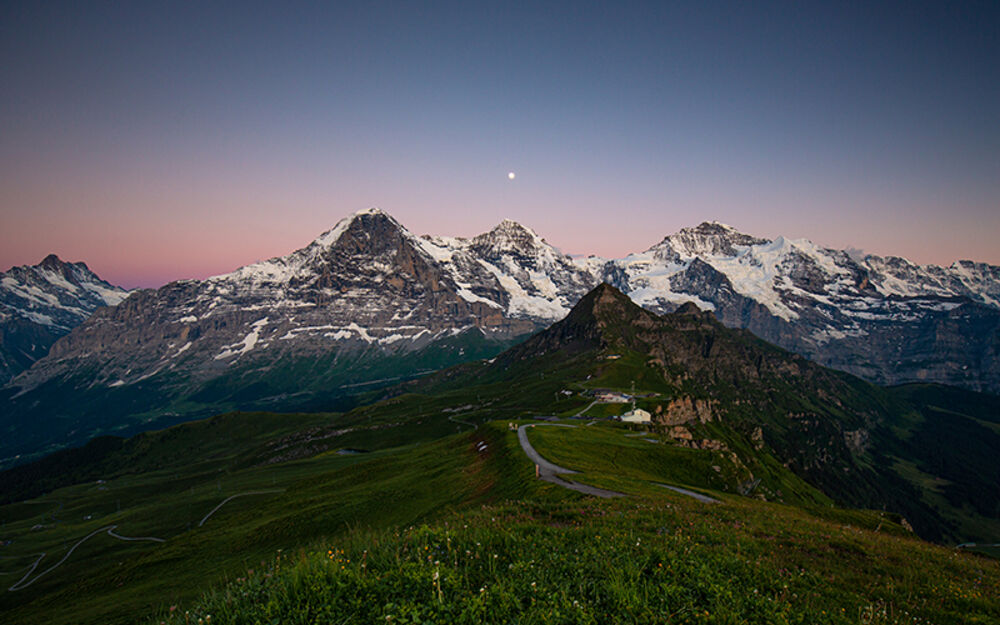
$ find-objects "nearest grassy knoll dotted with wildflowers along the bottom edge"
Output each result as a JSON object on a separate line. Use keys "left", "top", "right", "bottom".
{"left": 155, "top": 496, "right": 1000, "bottom": 624}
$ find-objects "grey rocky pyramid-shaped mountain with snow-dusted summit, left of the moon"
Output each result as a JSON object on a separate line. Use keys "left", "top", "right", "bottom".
{"left": 9, "top": 209, "right": 548, "bottom": 390}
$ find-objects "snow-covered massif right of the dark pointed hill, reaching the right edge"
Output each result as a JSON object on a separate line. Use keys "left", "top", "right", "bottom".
{"left": 610, "top": 222, "right": 1000, "bottom": 392}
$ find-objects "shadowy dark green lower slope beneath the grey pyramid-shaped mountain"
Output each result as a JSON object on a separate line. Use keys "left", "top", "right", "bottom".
{"left": 0, "top": 330, "right": 516, "bottom": 468}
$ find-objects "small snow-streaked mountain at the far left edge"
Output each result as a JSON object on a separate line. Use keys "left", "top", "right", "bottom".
{"left": 0, "top": 254, "right": 128, "bottom": 383}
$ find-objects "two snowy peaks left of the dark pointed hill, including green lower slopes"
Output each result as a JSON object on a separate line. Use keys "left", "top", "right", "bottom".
{"left": 0, "top": 209, "right": 608, "bottom": 464}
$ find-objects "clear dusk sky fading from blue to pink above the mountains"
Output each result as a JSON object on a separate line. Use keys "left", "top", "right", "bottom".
{"left": 0, "top": 0, "right": 1000, "bottom": 287}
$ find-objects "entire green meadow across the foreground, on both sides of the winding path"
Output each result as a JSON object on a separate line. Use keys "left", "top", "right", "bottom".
{"left": 0, "top": 410, "right": 1000, "bottom": 623}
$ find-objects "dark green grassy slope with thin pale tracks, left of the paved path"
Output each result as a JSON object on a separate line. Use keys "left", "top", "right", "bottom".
{"left": 0, "top": 417, "right": 563, "bottom": 624}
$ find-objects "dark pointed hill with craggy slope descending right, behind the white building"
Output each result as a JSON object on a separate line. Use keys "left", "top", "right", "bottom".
{"left": 415, "top": 284, "right": 1000, "bottom": 540}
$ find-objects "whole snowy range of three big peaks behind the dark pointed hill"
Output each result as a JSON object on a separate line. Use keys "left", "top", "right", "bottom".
{"left": 0, "top": 209, "right": 1000, "bottom": 463}
